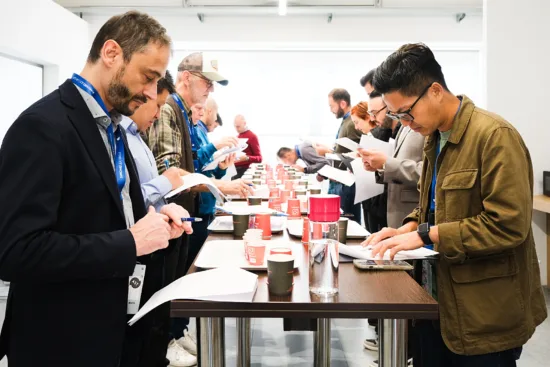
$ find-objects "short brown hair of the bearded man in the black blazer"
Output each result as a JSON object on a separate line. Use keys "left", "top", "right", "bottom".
{"left": 88, "top": 11, "right": 172, "bottom": 63}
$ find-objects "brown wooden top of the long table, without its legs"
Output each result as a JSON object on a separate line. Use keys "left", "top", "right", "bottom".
{"left": 171, "top": 230, "right": 439, "bottom": 319}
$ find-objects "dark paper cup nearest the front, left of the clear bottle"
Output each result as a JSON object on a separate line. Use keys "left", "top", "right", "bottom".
{"left": 267, "top": 254, "right": 294, "bottom": 296}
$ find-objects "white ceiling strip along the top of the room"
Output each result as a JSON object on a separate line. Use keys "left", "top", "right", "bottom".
{"left": 54, "top": 0, "right": 483, "bottom": 15}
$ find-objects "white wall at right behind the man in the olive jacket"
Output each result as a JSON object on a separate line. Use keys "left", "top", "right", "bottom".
{"left": 483, "top": 0, "right": 550, "bottom": 284}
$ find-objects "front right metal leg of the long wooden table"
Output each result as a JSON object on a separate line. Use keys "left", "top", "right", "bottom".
{"left": 378, "top": 319, "right": 407, "bottom": 367}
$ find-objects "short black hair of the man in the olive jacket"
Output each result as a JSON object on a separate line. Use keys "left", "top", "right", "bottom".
{"left": 373, "top": 43, "right": 449, "bottom": 97}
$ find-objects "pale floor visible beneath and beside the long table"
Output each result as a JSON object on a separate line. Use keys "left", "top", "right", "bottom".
{"left": 0, "top": 290, "right": 550, "bottom": 367}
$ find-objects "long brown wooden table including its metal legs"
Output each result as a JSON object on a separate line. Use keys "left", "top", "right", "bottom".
{"left": 171, "top": 230, "right": 439, "bottom": 367}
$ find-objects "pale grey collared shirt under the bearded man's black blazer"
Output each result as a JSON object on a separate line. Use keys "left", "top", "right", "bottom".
{"left": 75, "top": 84, "right": 134, "bottom": 228}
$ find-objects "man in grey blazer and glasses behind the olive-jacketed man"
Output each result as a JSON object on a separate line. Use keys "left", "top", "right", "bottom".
{"left": 360, "top": 90, "right": 424, "bottom": 228}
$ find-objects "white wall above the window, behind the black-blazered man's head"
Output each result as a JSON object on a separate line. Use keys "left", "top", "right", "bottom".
{"left": 0, "top": 0, "right": 90, "bottom": 93}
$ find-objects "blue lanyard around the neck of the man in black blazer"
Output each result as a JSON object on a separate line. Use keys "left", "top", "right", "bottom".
{"left": 71, "top": 74, "right": 126, "bottom": 200}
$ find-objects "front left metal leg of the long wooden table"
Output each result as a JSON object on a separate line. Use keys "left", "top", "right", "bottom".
{"left": 200, "top": 317, "right": 225, "bottom": 367}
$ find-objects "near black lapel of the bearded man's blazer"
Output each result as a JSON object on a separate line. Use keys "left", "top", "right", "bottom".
{"left": 59, "top": 80, "right": 125, "bottom": 219}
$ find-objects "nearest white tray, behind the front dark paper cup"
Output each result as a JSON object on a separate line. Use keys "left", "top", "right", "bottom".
{"left": 195, "top": 240, "right": 304, "bottom": 270}
